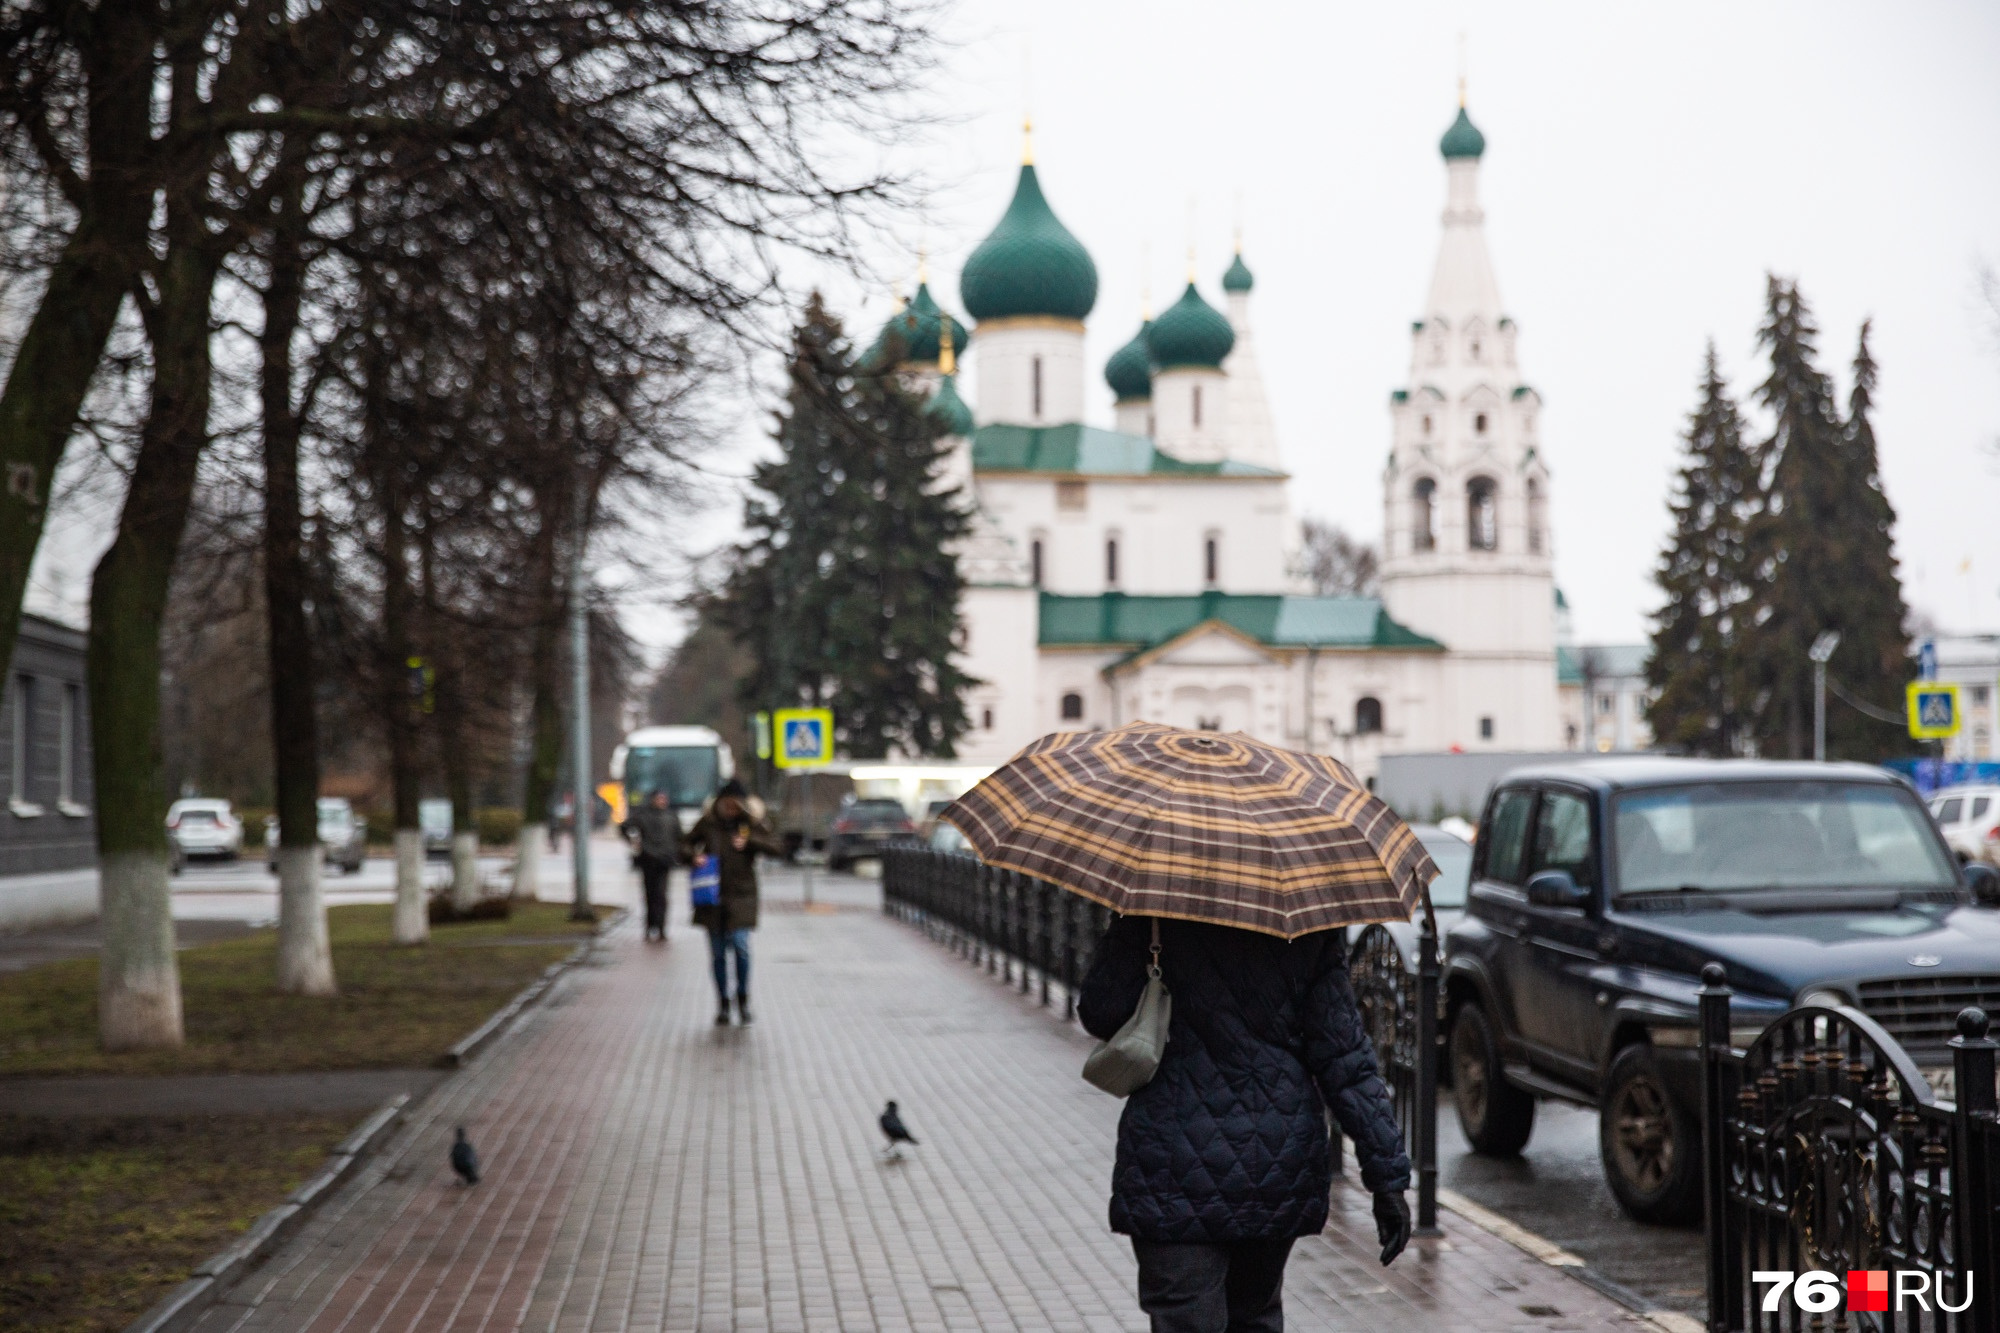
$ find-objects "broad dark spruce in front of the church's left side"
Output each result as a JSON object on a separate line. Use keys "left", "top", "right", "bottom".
{"left": 718, "top": 294, "right": 976, "bottom": 759}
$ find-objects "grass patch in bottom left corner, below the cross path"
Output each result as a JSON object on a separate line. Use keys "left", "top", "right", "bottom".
{"left": 0, "top": 1115, "right": 354, "bottom": 1333}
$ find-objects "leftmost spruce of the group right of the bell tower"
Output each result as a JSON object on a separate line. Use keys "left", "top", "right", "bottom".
{"left": 1646, "top": 342, "right": 1762, "bottom": 757}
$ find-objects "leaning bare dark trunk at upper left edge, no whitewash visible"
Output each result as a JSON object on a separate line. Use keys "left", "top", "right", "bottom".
{"left": 0, "top": 0, "right": 156, "bottom": 664}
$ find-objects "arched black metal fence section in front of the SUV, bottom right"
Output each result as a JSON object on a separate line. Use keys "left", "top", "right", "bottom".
{"left": 1700, "top": 963, "right": 2000, "bottom": 1333}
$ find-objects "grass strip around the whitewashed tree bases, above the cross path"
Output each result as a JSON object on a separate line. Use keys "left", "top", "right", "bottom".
{"left": 0, "top": 903, "right": 608, "bottom": 1077}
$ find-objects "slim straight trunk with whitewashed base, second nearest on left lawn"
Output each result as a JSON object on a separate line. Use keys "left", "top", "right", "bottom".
{"left": 262, "top": 208, "right": 338, "bottom": 995}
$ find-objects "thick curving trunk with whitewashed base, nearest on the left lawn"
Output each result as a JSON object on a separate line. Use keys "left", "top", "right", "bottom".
{"left": 88, "top": 236, "right": 220, "bottom": 1051}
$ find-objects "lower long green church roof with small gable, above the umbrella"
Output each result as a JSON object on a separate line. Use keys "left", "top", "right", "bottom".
{"left": 1040, "top": 592, "right": 1444, "bottom": 652}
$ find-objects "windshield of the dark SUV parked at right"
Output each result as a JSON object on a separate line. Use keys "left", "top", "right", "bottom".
{"left": 1612, "top": 783, "right": 1958, "bottom": 893}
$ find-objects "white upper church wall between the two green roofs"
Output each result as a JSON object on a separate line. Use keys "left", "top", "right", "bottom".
{"left": 980, "top": 474, "right": 1290, "bottom": 596}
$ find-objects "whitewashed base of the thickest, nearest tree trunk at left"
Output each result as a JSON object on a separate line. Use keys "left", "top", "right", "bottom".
{"left": 98, "top": 851, "right": 184, "bottom": 1051}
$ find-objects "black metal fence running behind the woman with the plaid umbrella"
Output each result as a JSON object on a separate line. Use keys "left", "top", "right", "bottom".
{"left": 882, "top": 847, "right": 1438, "bottom": 1235}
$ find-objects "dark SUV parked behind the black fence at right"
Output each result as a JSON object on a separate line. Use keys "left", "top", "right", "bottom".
{"left": 1444, "top": 759, "right": 2000, "bottom": 1223}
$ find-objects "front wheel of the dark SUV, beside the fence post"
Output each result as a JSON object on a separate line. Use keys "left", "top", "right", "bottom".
{"left": 1598, "top": 1047, "right": 1702, "bottom": 1225}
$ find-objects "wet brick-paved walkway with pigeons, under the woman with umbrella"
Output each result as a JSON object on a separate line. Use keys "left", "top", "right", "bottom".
{"left": 196, "top": 877, "right": 1664, "bottom": 1333}
